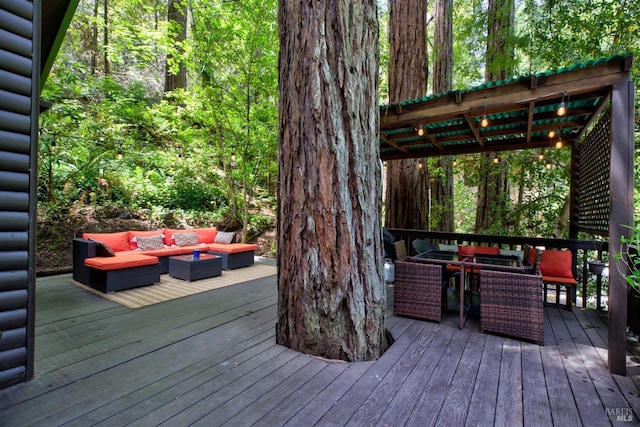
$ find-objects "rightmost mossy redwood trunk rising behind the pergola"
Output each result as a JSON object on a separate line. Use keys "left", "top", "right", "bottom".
{"left": 475, "top": 0, "right": 515, "bottom": 233}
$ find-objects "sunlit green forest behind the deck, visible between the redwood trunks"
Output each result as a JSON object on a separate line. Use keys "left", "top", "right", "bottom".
{"left": 37, "top": 0, "right": 640, "bottom": 272}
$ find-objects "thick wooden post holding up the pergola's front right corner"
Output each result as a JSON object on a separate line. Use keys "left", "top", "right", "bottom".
{"left": 608, "top": 80, "right": 634, "bottom": 375}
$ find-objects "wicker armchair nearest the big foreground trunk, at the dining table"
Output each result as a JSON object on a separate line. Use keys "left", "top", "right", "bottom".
{"left": 393, "top": 261, "right": 444, "bottom": 322}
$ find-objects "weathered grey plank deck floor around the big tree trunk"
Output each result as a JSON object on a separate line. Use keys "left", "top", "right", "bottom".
{"left": 0, "top": 260, "right": 640, "bottom": 427}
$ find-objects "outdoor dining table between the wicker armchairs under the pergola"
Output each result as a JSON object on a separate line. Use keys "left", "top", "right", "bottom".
{"left": 411, "top": 251, "right": 531, "bottom": 329}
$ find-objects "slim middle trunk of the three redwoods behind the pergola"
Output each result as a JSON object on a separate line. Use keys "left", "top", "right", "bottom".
{"left": 429, "top": 0, "right": 455, "bottom": 231}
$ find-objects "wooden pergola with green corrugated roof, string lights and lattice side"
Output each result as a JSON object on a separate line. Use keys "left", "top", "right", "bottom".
{"left": 380, "top": 55, "right": 634, "bottom": 375}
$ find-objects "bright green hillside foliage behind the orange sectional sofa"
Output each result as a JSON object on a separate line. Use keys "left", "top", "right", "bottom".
{"left": 38, "top": 0, "right": 278, "bottom": 241}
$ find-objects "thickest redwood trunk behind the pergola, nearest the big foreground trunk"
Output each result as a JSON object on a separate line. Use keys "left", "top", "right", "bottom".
{"left": 385, "top": 0, "right": 429, "bottom": 230}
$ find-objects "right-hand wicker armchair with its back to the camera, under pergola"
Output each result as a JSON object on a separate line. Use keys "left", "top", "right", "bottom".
{"left": 480, "top": 269, "right": 544, "bottom": 344}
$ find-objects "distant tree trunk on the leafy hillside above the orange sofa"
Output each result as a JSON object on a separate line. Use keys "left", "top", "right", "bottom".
{"left": 164, "top": 0, "right": 187, "bottom": 92}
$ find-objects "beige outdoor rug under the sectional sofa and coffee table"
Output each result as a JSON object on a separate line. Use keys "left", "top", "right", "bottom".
{"left": 69, "top": 264, "right": 276, "bottom": 309}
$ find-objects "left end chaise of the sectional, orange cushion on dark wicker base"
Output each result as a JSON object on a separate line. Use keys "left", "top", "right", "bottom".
{"left": 84, "top": 254, "right": 160, "bottom": 293}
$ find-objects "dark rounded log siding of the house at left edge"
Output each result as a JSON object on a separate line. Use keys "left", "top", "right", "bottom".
{"left": 0, "top": 0, "right": 40, "bottom": 388}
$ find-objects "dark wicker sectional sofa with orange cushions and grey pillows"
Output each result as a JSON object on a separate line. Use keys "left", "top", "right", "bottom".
{"left": 73, "top": 227, "right": 258, "bottom": 293}
